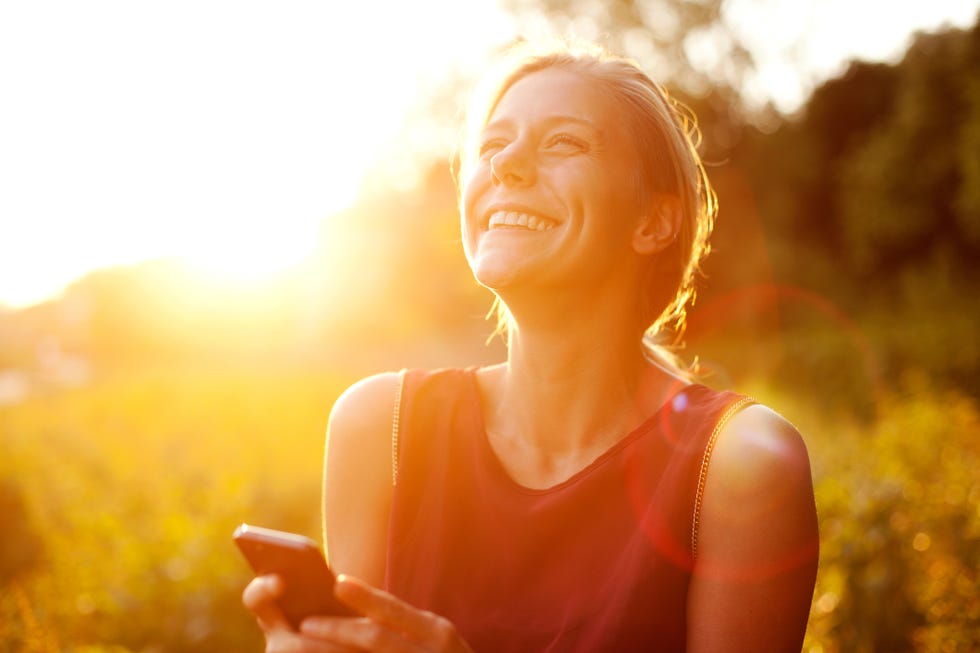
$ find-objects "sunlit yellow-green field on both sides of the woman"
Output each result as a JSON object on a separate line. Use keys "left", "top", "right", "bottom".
{"left": 0, "top": 369, "right": 980, "bottom": 653}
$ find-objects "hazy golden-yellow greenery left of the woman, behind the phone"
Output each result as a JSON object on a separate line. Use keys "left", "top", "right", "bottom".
{"left": 0, "top": 370, "right": 345, "bottom": 653}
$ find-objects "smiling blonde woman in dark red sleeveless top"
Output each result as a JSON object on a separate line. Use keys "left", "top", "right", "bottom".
{"left": 244, "top": 42, "right": 817, "bottom": 652}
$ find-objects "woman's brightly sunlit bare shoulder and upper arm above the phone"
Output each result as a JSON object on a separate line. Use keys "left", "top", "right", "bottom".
{"left": 323, "top": 372, "right": 400, "bottom": 584}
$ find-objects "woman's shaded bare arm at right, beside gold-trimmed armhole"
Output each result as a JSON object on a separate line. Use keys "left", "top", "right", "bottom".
{"left": 688, "top": 406, "right": 819, "bottom": 653}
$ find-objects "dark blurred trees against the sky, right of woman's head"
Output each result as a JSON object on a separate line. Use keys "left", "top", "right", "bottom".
{"left": 744, "top": 20, "right": 980, "bottom": 294}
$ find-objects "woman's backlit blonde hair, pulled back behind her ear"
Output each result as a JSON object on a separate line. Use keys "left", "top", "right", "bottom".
{"left": 457, "top": 40, "right": 718, "bottom": 371}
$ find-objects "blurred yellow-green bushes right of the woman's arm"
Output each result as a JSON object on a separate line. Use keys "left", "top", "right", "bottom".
{"left": 759, "top": 374, "right": 980, "bottom": 653}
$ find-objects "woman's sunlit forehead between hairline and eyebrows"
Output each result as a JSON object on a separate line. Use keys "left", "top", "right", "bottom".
{"left": 487, "top": 68, "right": 617, "bottom": 131}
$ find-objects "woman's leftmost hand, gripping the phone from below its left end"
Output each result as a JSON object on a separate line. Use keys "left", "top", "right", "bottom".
{"left": 242, "top": 575, "right": 354, "bottom": 653}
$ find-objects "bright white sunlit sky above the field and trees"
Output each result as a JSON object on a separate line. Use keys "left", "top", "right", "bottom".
{"left": 0, "top": 0, "right": 980, "bottom": 308}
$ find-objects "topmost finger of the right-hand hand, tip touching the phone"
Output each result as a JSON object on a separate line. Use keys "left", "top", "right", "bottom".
{"left": 334, "top": 575, "right": 455, "bottom": 646}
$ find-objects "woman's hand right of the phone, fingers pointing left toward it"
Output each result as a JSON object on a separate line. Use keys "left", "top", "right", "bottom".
{"left": 300, "top": 576, "right": 473, "bottom": 653}
